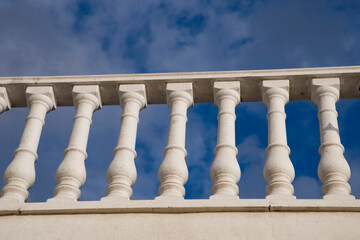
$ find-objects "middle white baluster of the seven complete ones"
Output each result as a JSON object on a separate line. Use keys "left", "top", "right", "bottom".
{"left": 157, "top": 83, "right": 193, "bottom": 199}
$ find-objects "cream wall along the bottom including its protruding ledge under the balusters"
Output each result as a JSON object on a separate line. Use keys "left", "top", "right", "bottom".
{"left": 0, "top": 199, "right": 360, "bottom": 240}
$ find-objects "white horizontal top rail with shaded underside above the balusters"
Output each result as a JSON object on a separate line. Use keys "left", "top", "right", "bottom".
{"left": 0, "top": 66, "right": 360, "bottom": 107}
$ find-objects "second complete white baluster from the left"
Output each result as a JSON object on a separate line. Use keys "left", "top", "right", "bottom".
{"left": 48, "top": 86, "right": 101, "bottom": 201}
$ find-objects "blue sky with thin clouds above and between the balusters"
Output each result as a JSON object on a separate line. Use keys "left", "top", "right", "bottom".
{"left": 0, "top": 0, "right": 360, "bottom": 201}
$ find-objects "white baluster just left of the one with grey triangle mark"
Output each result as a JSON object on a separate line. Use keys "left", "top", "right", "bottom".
{"left": 262, "top": 80, "right": 295, "bottom": 199}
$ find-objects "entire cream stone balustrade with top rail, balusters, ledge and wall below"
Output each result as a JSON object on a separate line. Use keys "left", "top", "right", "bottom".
{"left": 0, "top": 67, "right": 360, "bottom": 239}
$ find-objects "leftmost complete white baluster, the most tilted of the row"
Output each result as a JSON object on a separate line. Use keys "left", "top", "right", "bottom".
{"left": 2, "top": 87, "right": 56, "bottom": 202}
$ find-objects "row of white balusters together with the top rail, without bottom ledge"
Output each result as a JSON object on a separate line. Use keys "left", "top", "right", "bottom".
{"left": 0, "top": 67, "right": 360, "bottom": 205}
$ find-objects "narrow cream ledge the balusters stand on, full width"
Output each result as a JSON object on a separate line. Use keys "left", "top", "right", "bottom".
{"left": 0, "top": 199, "right": 360, "bottom": 216}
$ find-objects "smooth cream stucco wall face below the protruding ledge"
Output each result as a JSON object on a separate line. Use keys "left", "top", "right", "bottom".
{"left": 0, "top": 212, "right": 360, "bottom": 240}
